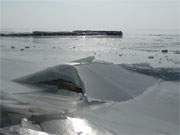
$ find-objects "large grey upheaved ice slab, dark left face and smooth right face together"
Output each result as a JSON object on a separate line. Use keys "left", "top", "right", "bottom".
{"left": 15, "top": 62, "right": 156, "bottom": 101}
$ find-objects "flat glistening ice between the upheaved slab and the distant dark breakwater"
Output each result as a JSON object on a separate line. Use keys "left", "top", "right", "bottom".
{"left": 1, "top": 30, "right": 180, "bottom": 67}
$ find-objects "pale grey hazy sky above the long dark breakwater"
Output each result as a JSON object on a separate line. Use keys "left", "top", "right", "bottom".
{"left": 0, "top": 0, "right": 180, "bottom": 31}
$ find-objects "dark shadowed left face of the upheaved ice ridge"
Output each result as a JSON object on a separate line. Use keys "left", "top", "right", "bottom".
{"left": 14, "top": 65, "right": 84, "bottom": 93}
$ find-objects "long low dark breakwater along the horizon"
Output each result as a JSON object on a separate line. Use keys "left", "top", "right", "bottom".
{"left": 0, "top": 30, "right": 123, "bottom": 37}
